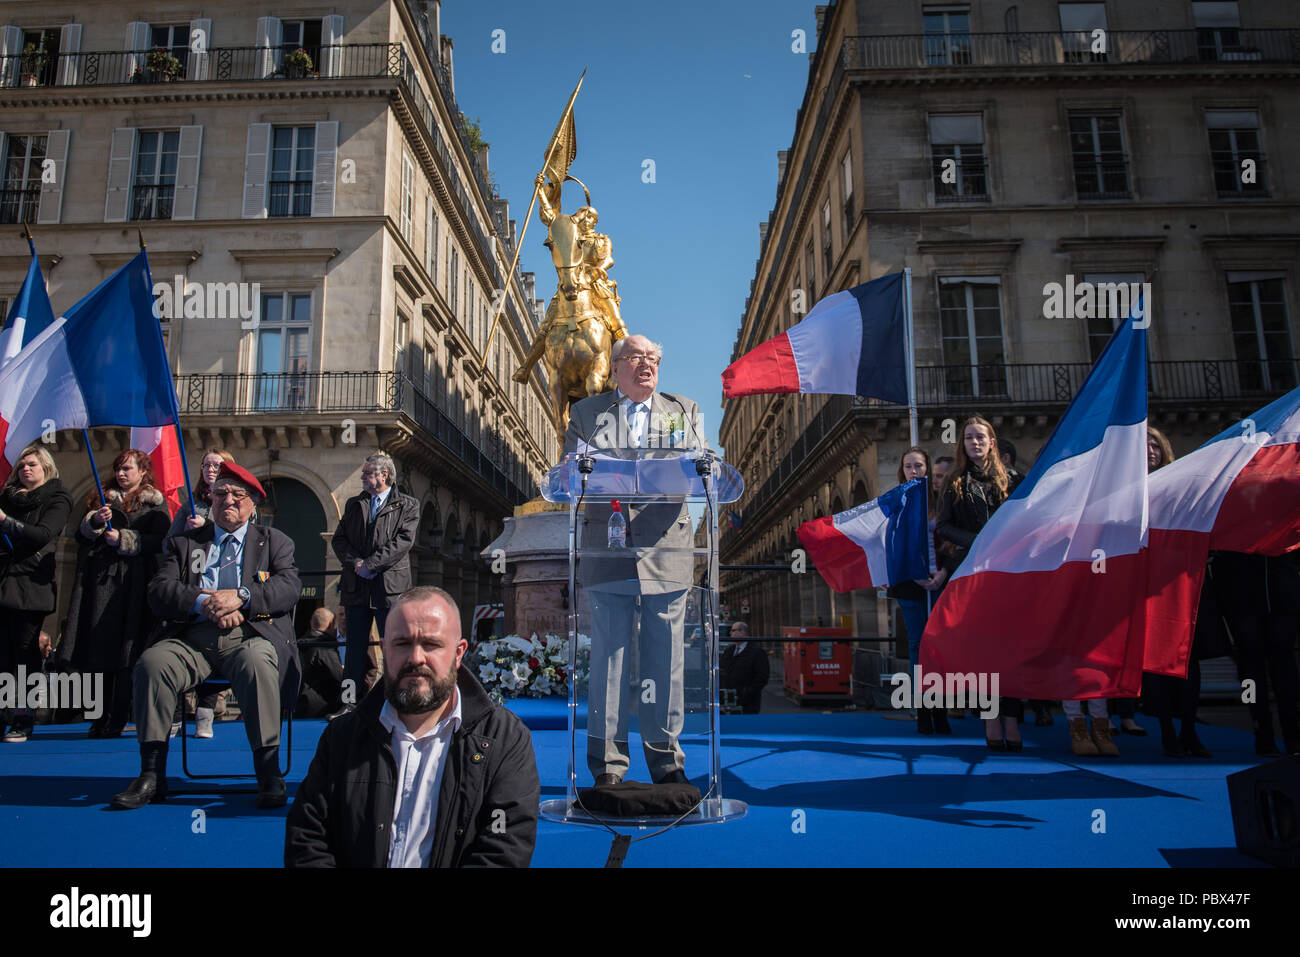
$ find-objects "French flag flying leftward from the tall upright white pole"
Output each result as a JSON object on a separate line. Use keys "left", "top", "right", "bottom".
{"left": 723, "top": 273, "right": 904, "bottom": 403}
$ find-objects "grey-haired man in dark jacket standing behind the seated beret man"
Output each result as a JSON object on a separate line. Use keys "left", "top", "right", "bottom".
{"left": 333, "top": 452, "right": 420, "bottom": 710}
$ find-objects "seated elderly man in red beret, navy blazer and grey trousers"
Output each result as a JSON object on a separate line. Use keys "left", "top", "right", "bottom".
{"left": 112, "top": 462, "right": 302, "bottom": 810}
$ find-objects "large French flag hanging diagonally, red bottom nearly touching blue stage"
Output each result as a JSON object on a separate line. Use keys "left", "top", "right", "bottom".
{"left": 920, "top": 313, "right": 1149, "bottom": 700}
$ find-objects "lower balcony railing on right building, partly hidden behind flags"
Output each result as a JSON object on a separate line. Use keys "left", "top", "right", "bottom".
{"left": 741, "top": 358, "right": 1300, "bottom": 518}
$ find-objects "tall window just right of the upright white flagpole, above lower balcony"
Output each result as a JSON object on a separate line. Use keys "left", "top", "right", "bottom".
{"left": 939, "top": 277, "right": 1006, "bottom": 397}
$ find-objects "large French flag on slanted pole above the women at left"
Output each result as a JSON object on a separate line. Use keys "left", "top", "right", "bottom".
{"left": 0, "top": 250, "right": 183, "bottom": 504}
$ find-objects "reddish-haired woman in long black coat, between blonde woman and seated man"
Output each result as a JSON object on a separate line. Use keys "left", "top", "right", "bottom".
{"left": 59, "top": 449, "right": 172, "bottom": 737}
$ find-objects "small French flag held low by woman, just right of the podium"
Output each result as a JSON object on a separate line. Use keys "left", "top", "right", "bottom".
{"left": 797, "top": 479, "right": 930, "bottom": 592}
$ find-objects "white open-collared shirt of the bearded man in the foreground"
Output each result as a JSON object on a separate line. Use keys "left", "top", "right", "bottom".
{"left": 380, "top": 688, "right": 460, "bottom": 867}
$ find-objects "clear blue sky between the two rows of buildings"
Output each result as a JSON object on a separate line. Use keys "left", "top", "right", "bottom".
{"left": 442, "top": 0, "right": 816, "bottom": 447}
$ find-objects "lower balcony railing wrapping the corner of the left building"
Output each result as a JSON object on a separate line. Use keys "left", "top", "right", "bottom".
{"left": 176, "top": 372, "right": 537, "bottom": 505}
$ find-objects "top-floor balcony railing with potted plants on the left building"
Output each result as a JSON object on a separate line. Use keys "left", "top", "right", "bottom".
{"left": 0, "top": 43, "right": 403, "bottom": 87}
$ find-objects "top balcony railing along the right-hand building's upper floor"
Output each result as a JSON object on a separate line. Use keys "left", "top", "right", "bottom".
{"left": 841, "top": 27, "right": 1300, "bottom": 70}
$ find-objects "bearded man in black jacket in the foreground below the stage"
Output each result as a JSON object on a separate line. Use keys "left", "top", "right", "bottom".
{"left": 285, "top": 588, "right": 541, "bottom": 867}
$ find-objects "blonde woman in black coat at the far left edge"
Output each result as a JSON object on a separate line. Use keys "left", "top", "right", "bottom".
{"left": 0, "top": 445, "right": 73, "bottom": 742}
